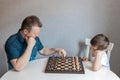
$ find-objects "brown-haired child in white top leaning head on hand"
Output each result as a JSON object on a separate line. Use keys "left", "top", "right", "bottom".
{"left": 83, "top": 34, "right": 110, "bottom": 71}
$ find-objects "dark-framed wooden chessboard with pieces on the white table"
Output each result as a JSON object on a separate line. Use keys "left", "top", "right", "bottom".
{"left": 45, "top": 57, "right": 85, "bottom": 74}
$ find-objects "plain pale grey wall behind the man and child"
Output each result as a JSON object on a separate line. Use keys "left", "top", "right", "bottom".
{"left": 0, "top": 0, "right": 120, "bottom": 76}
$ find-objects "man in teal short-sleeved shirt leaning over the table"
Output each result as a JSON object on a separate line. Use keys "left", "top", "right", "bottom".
{"left": 5, "top": 16, "right": 66, "bottom": 71}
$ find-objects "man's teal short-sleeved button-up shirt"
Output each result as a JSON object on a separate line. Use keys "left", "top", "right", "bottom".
{"left": 5, "top": 32, "right": 43, "bottom": 69}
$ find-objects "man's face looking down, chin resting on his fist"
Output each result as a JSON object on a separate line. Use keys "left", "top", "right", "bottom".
{"left": 27, "top": 26, "right": 40, "bottom": 38}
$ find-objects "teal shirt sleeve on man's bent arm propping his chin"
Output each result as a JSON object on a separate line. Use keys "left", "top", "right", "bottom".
{"left": 5, "top": 44, "right": 20, "bottom": 60}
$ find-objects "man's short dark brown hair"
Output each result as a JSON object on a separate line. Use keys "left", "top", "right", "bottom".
{"left": 20, "top": 15, "right": 42, "bottom": 31}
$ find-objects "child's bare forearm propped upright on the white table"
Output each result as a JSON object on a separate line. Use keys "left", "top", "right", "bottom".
{"left": 92, "top": 51, "right": 102, "bottom": 71}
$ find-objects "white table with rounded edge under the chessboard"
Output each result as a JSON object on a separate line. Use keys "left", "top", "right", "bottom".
{"left": 1, "top": 58, "right": 120, "bottom": 80}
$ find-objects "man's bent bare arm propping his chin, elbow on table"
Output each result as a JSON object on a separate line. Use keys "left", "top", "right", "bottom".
{"left": 10, "top": 38, "right": 35, "bottom": 71}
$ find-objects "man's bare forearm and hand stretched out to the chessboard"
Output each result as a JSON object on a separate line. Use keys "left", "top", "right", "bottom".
{"left": 39, "top": 48, "right": 66, "bottom": 57}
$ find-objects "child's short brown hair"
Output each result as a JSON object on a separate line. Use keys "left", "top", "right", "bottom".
{"left": 90, "top": 34, "right": 109, "bottom": 50}
